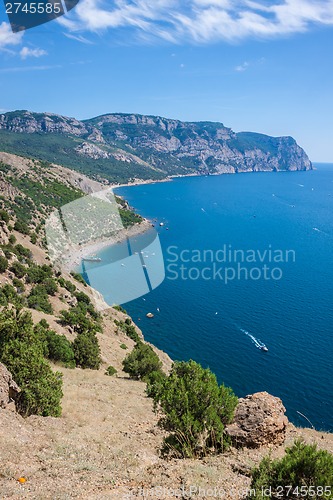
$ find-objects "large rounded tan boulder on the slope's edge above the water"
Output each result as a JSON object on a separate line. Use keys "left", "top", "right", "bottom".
{"left": 226, "top": 392, "right": 288, "bottom": 448}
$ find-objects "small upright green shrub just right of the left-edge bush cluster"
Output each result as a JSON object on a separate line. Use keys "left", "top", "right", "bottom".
{"left": 73, "top": 332, "right": 101, "bottom": 370}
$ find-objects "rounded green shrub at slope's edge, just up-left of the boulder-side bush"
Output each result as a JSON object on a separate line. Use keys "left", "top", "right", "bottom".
{"left": 123, "top": 342, "right": 162, "bottom": 380}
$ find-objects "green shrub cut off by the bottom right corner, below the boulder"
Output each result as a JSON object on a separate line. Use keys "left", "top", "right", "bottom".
{"left": 251, "top": 440, "right": 333, "bottom": 499}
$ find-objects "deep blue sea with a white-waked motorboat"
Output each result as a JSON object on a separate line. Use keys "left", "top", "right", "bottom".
{"left": 79, "top": 164, "right": 333, "bottom": 431}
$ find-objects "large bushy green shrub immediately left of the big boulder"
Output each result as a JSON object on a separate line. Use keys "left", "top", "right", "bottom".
{"left": 148, "top": 361, "right": 237, "bottom": 457}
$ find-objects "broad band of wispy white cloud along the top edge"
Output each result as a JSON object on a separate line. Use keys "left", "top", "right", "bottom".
{"left": 59, "top": 0, "right": 333, "bottom": 43}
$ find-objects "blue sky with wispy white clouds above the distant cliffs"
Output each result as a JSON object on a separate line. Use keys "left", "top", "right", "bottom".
{"left": 0, "top": 0, "right": 333, "bottom": 162}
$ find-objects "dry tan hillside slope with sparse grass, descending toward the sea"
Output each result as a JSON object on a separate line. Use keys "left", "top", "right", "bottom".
{"left": 0, "top": 153, "right": 333, "bottom": 500}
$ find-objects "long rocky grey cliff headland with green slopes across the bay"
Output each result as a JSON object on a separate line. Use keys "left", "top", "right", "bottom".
{"left": 0, "top": 111, "right": 312, "bottom": 180}
